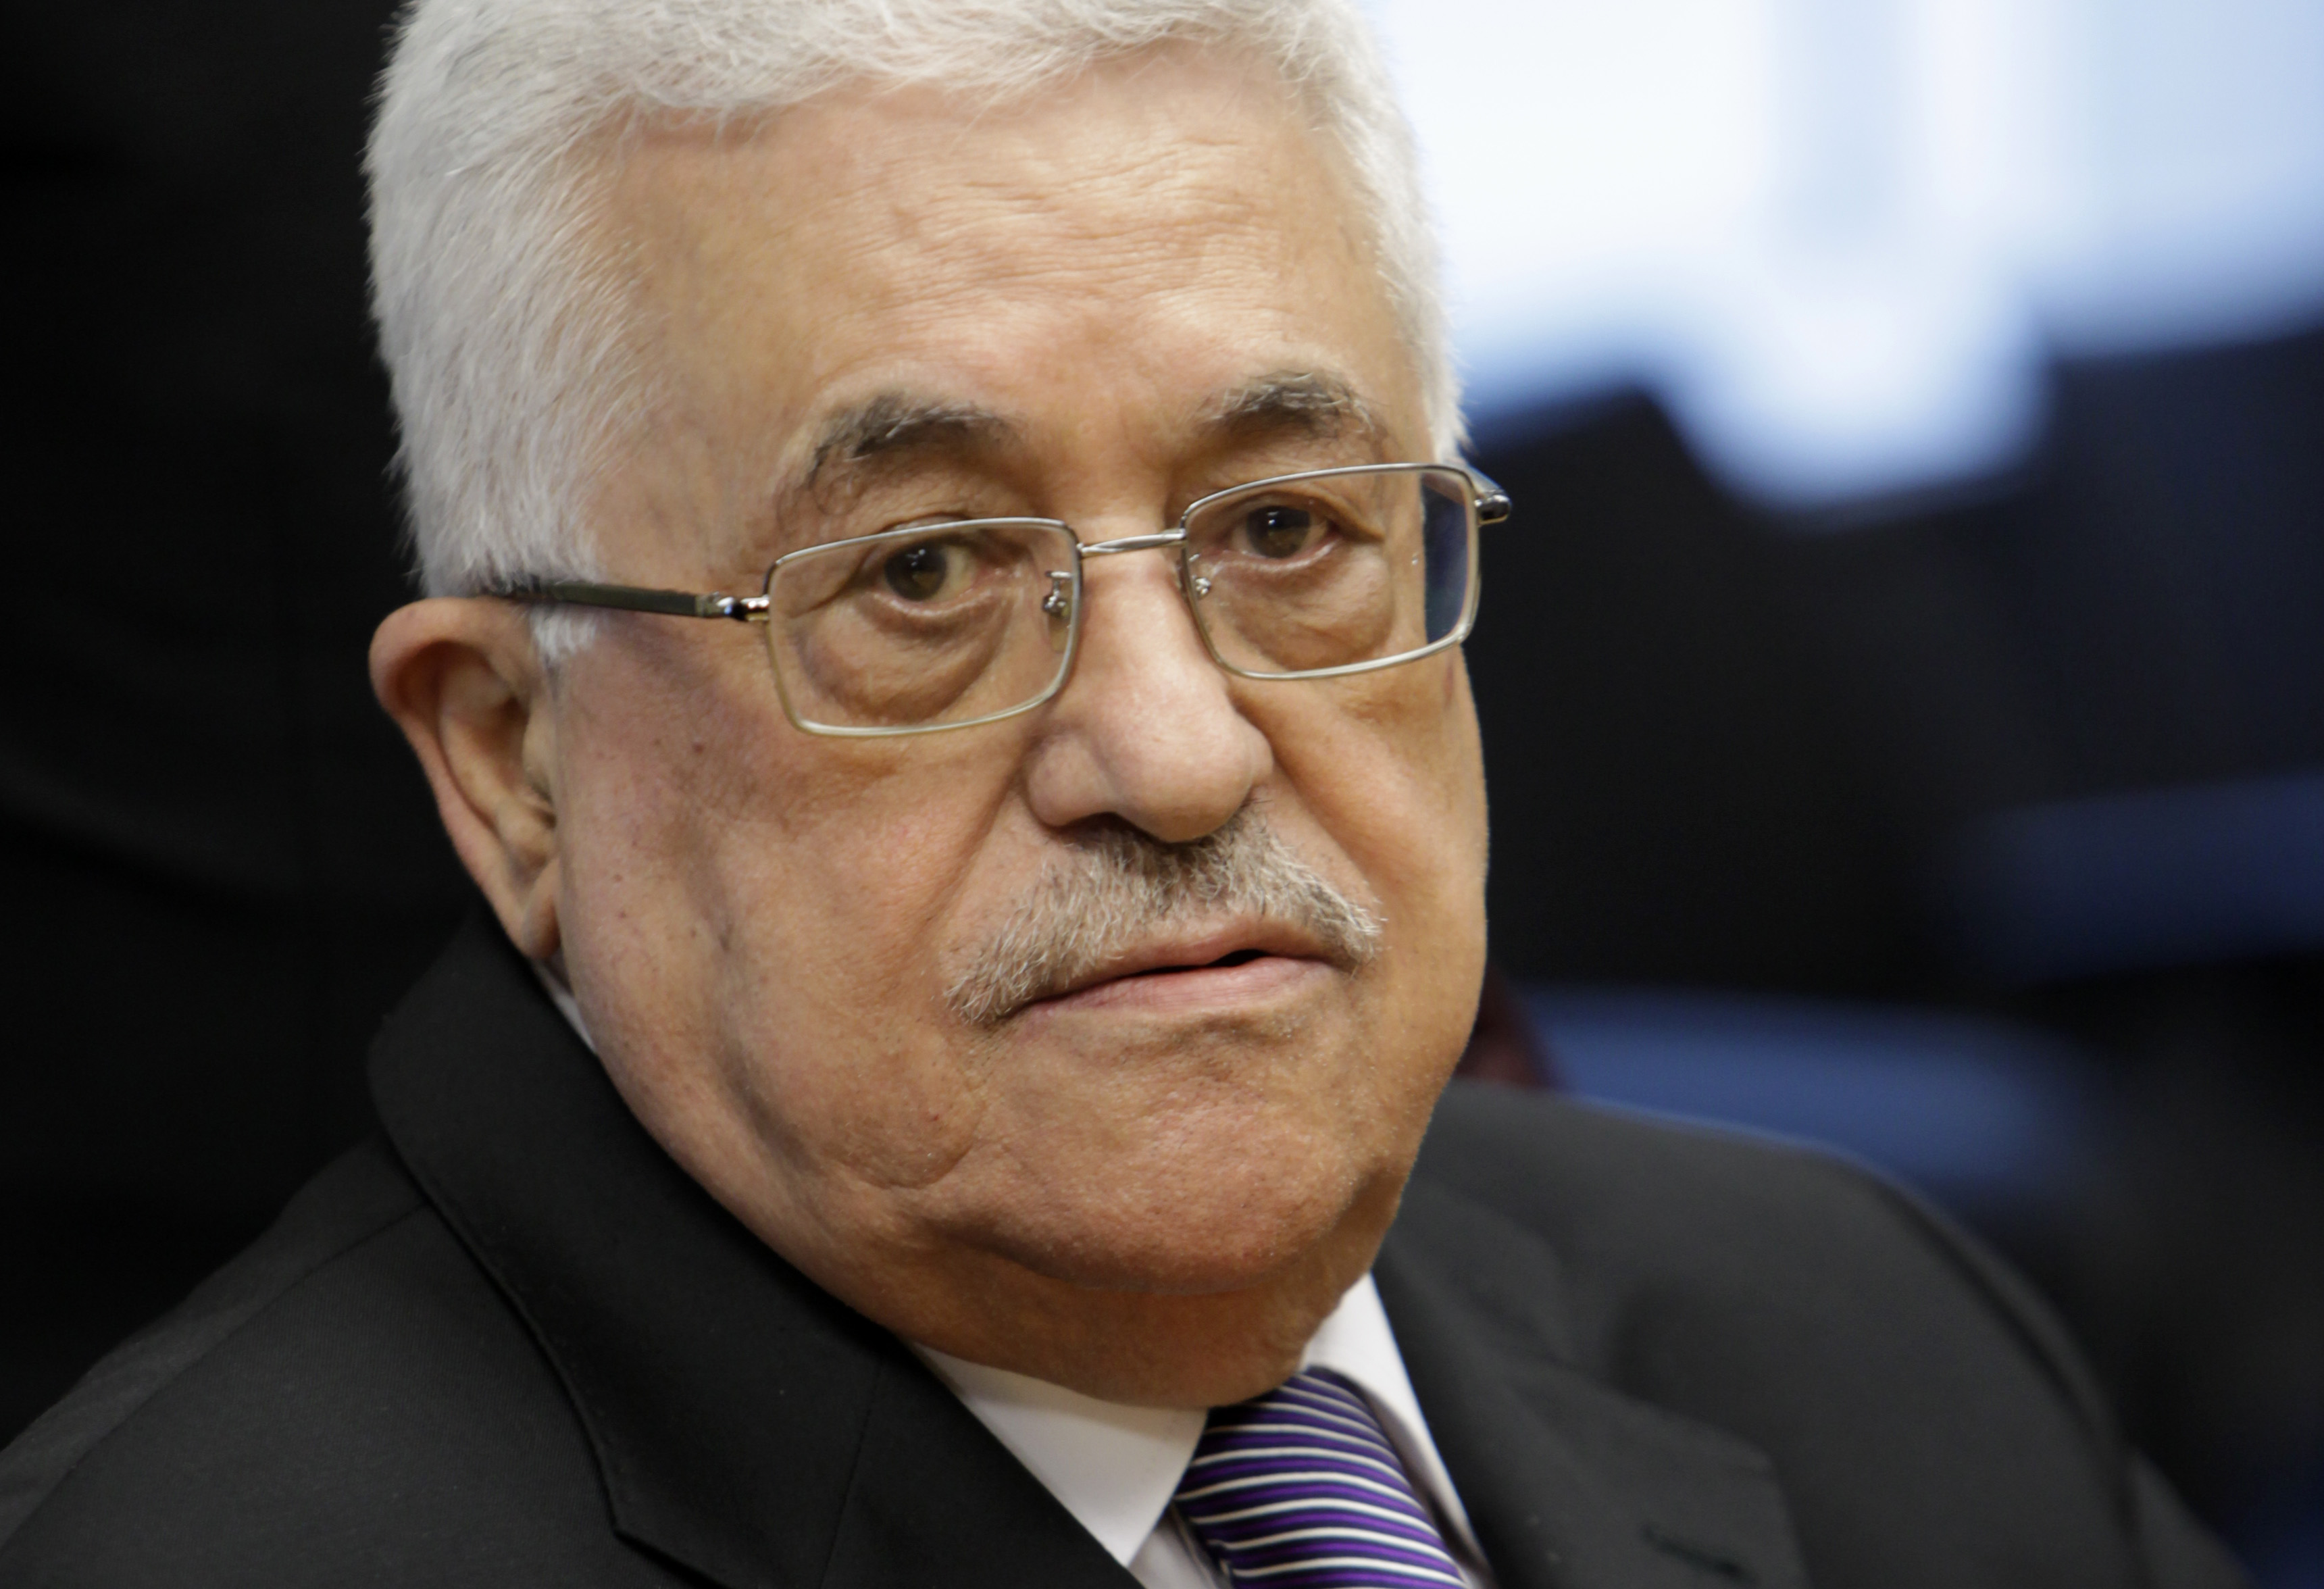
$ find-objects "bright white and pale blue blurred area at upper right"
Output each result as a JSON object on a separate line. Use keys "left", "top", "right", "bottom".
{"left": 1373, "top": 0, "right": 2324, "bottom": 504}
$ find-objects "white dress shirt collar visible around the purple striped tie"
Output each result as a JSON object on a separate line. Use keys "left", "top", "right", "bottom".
{"left": 534, "top": 962, "right": 1494, "bottom": 1589}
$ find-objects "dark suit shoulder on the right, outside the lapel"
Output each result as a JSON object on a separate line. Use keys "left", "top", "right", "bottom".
{"left": 1409, "top": 1087, "right": 2196, "bottom": 1582}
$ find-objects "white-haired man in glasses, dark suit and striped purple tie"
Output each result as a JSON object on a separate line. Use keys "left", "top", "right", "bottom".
{"left": 0, "top": 0, "right": 2233, "bottom": 1589}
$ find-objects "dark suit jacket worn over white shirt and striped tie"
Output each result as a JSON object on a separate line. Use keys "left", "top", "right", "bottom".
{"left": 0, "top": 927, "right": 2233, "bottom": 1589}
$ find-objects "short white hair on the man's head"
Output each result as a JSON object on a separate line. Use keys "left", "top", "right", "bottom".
{"left": 365, "top": 0, "right": 1459, "bottom": 622}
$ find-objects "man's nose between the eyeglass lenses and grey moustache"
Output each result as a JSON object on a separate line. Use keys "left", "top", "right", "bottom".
{"left": 1025, "top": 551, "right": 1273, "bottom": 843}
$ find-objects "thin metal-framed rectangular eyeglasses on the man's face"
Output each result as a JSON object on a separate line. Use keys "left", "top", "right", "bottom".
{"left": 492, "top": 465, "right": 1511, "bottom": 736}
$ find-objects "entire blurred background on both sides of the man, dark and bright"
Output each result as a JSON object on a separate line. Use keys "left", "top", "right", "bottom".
{"left": 0, "top": 0, "right": 2324, "bottom": 1589}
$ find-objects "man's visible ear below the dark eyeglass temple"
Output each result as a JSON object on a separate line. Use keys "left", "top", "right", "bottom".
{"left": 372, "top": 597, "right": 560, "bottom": 959}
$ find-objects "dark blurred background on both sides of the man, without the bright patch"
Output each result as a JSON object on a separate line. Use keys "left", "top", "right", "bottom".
{"left": 0, "top": 0, "right": 2324, "bottom": 1587}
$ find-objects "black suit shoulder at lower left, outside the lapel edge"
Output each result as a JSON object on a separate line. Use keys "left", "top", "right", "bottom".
{"left": 0, "top": 1145, "right": 646, "bottom": 1589}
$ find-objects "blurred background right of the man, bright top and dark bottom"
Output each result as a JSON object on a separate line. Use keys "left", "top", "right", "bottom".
{"left": 1373, "top": 0, "right": 2324, "bottom": 1587}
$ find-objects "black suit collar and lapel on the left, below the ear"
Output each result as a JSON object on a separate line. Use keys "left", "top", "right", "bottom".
{"left": 372, "top": 922, "right": 1130, "bottom": 1589}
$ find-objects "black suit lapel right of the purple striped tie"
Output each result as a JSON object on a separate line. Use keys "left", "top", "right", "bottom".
{"left": 1373, "top": 1180, "right": 1806, "bottom": 1589}
